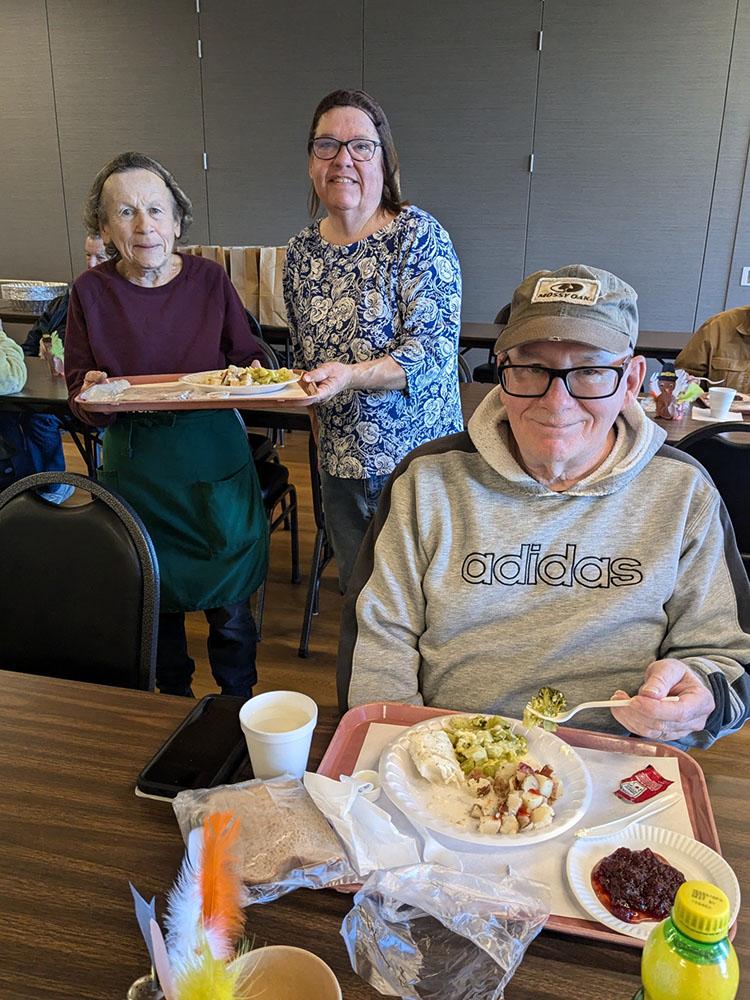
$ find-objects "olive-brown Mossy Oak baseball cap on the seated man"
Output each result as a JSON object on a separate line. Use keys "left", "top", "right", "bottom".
{"left": 495, "top": 264, "right": 638, "bottom": 354}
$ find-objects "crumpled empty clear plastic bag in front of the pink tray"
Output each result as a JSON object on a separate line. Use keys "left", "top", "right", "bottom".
{"left": 341, "top": 865, "right": 550, "bottom": 1000}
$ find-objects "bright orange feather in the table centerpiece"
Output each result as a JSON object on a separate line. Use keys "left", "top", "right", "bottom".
{"left": 200, "top": 813, "right": 245, "bottom": 958}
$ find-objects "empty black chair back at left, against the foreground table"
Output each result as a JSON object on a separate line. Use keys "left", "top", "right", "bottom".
{"left": 0, "top": 472, "right": 159, "bottom": 691}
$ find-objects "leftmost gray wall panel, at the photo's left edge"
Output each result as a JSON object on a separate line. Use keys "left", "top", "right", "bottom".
{"left": 0, "top": 0, "right": 71, "bottom": 281}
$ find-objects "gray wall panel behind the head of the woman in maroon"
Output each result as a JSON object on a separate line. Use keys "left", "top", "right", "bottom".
{"left": 48, "top": 0, "right": 208, "bottom": 258}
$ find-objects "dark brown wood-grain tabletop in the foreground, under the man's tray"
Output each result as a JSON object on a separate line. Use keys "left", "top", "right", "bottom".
{"left": 0, "top": 671, "right": 750, "bottom": 1000}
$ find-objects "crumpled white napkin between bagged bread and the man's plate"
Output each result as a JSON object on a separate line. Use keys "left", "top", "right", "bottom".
{"left": 303, "top": 771, "right": 421, "bottom": 877}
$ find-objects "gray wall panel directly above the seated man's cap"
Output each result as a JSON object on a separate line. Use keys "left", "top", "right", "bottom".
{"left": 527, "top": 0, "right": 736, "bottom": 330}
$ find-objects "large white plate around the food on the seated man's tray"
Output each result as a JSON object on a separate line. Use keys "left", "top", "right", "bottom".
{"left": 380, "top": 712, "right": 591, "bottom": 848}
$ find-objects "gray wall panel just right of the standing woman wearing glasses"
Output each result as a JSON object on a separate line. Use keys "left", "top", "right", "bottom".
{"left": 364, "top": 0, "right": 541, "bottom": 322}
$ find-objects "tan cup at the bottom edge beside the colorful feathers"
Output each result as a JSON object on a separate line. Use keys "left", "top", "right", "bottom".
{"left": 229, "top": 944, "right": 342, "bottom": 1000}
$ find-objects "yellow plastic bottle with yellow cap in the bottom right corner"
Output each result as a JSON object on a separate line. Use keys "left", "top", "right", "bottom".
{"left": 633, "top": 882, "right": 740, "bottom": 1000}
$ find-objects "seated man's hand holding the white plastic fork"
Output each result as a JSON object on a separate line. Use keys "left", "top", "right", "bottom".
{"left": 610, "top": 659, "right": 716, "bottom": 741}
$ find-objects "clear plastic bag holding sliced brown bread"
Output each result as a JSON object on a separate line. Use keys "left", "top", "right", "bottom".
{"left": 173, "top": 776, "right": 356, "bottom": 906}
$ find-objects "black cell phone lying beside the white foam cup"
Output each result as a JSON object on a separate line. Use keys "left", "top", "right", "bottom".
{"left": 137, "top": 694, "right": 248, "bottom": 799}
